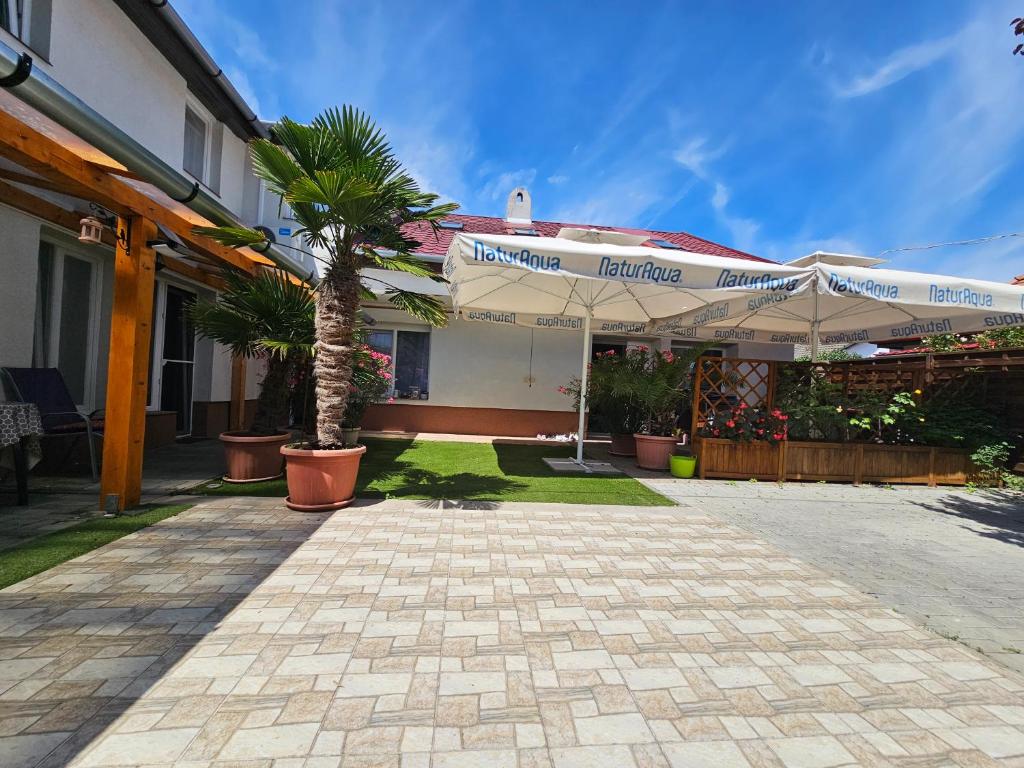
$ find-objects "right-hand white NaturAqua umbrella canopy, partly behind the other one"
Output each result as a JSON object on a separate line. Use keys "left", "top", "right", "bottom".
{"left": 656, "top": 253, "right": 1024, "bottom": 359}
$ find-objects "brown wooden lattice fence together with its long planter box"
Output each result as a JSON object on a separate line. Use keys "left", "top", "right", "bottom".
{"left": 691, "top": 349, "right": 1024, "bottom": 485}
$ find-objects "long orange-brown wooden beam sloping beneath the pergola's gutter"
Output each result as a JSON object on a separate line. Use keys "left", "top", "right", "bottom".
{"left": 0, "top": 110, "right": 270, "bottom": 273}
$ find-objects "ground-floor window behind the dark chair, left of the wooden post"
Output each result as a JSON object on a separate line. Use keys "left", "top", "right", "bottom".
{"left": 32, "top": 241, "right": 100, "bottom": 410}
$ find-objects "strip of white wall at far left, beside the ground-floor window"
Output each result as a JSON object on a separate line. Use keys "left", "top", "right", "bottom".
{"left": 0, "top": 206, "right": 40, "bottom": 367}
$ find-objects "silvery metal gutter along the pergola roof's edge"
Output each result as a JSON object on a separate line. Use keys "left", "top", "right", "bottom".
{"left": 0, "top": 37, "right": 315, "bottom": 282}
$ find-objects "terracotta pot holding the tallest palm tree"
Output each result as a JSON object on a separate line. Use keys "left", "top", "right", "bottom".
{"left": 281, "top": 445, "right": 367, "bottom": 512}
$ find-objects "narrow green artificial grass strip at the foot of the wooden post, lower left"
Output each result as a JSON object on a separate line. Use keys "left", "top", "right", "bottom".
{"left": 0, "top": 504, "right": 193, "bottom": 589}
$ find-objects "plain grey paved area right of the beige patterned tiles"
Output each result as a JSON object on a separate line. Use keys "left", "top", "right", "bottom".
{"left": 641, "top": 475, "right": 1024, "bottom": 671}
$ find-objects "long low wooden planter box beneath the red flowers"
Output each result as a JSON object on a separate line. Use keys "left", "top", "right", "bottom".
{"left": 694, "top": 437, "right": 972, "bottom": 485}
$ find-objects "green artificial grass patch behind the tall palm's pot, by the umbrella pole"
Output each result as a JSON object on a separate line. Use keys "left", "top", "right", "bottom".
{"left": 195, "top": 438, "right": 672, "bottom": 507}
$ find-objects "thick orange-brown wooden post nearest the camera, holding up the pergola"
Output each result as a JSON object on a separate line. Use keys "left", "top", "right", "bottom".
{"left": 99, "top": 217, "right": 157, "bottom": 511}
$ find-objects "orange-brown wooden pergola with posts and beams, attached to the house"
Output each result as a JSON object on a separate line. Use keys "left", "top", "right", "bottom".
{"left": 0, "top": 92, "right": 273, "bottom": 510}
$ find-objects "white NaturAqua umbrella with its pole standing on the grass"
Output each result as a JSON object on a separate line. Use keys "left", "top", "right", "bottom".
{"left": 443, "top": 229, "right": 814, "bottom": 467}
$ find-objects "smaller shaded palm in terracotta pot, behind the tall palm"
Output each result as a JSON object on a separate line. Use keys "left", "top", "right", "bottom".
{"left": 188, "top": 269, "right": 313, "bottom": 482}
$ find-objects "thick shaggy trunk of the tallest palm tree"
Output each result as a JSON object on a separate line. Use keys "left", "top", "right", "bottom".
{"left": 313, "top": 264, "right": 359, "bottom": 449}
